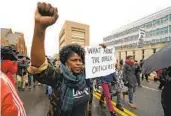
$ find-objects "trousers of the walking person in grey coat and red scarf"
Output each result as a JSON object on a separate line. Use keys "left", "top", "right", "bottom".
{"left": 128, "top": 87, "right": 136, "bottom": 104}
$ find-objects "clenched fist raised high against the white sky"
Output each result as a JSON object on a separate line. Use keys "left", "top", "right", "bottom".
{"left": 35, "top": 2, "right": 58, "bottom": 28}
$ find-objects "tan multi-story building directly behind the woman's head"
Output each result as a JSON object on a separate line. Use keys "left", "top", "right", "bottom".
{"left": 59, "top": 21, "right": 89, "bottom": 48}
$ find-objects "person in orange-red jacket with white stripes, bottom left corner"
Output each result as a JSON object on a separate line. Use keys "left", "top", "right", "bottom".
{"left": 0, "top": 71, "right": 26, "bottom": 116}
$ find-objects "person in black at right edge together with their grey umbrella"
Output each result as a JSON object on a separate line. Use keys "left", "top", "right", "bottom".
{"left": 143, "top": 42, "right": 171, "bottom": 116}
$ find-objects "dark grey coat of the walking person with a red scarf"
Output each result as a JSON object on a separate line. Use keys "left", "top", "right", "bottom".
{"left": 123, "top": 64, "right": 137, "bottom": 87}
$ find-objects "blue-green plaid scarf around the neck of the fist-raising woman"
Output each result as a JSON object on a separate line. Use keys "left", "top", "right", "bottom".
{"left": 60, "top": 63, "right": 86, "bottom": 113}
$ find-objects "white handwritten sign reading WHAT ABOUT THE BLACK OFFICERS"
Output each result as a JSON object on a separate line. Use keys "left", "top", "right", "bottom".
{"left": 85, "top": 46, "right": 116, "bottom": 79}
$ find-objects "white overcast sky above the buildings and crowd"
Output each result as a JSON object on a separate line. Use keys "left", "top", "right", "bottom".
{"left": 0, "top": 0, "right": 171, "bottom": 55}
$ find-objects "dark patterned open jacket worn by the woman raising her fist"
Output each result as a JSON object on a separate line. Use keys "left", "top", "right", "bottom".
{"left": 33, "top": 63, "right": 93, "bottom": 116}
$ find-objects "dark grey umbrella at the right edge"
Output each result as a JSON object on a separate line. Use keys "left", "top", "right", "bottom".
{"left": 143, "top": 42, "right": 171, "bottom": 74}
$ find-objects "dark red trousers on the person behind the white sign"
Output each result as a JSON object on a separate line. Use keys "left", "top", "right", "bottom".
{"left": 100, "top": 83, "right": 115, "bottom": 112}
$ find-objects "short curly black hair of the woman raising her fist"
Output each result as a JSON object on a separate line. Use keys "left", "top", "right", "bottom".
{"left": 59, "top": 44, "right": 85, "bottom": 64}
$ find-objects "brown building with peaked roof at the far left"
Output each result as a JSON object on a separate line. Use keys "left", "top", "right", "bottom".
{"left": 1, "top": 28, "right": 27, "bottom": 55}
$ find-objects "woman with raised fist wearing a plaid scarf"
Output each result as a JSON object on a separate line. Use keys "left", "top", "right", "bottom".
{"left": 29, "top": 3, "right": 93, "bottom": 116}
